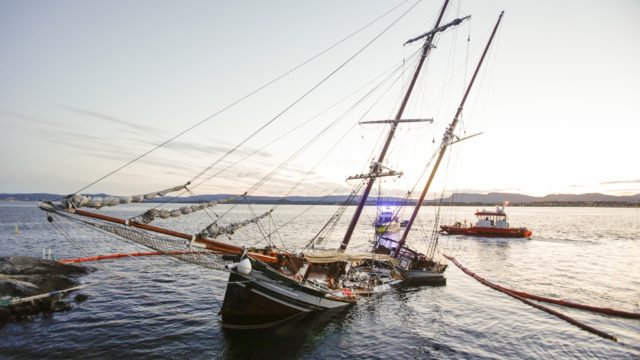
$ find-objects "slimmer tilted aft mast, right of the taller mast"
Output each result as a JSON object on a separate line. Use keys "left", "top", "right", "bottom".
{"left": 393, "top": 11, "right": 504, "bottom": 257}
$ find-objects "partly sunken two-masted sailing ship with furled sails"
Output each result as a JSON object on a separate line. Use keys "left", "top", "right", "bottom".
{"left": 40, "top": 0, "right": 502, "bottom": 329}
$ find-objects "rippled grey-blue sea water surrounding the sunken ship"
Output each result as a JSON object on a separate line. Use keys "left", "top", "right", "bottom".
{"left": 0, "top": 202, "right": 640, "bottom": 359}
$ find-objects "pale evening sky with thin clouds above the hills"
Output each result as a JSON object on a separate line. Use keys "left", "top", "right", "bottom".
{"left": 0, "top": 0, "right": 640, "bottom": 196}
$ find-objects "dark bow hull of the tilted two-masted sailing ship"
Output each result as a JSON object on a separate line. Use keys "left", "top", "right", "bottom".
{"left": 220, "top": 264, "right": 354, "bottom": 329}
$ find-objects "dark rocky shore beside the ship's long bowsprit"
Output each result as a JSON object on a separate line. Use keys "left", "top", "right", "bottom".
{"left": 0, "top": 256, "right": 92, "bottom": 325}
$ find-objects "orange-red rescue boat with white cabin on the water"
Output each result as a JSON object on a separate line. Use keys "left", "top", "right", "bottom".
{"left": 440, "top": 204, "right": 533, "bottom": 238}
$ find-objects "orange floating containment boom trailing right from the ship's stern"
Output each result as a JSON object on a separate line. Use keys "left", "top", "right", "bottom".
{"left": 444, "top": 255, "right": 640, "bottom": 341}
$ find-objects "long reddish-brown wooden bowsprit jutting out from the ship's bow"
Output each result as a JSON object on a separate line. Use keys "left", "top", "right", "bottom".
{"left": 74, "top": 210, "right": 279, "bottom": 263}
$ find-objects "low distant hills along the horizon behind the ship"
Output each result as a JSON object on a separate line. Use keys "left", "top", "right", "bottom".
{"left": 0, "top": 192, "right": 640, "bottom": 206}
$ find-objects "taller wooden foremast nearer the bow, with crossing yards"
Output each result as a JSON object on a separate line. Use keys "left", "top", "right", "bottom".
{"left": 339, "top": 0, "right": 449, "bottom": 251}
